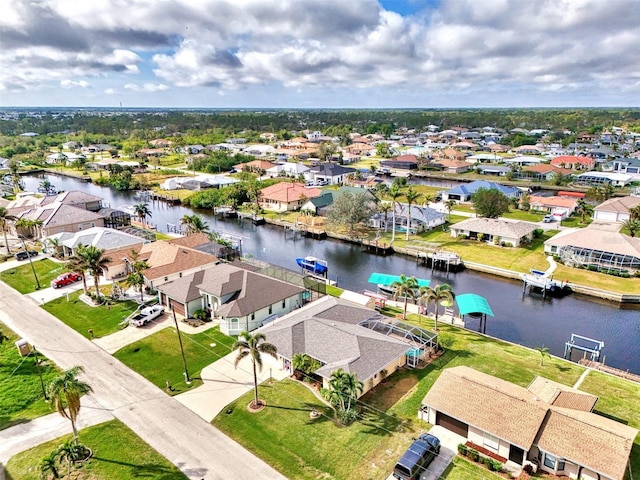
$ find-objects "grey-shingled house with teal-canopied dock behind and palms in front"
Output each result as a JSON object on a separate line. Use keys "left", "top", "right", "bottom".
{"left": 260, "top": 296, "right": 412, "bottom": 395}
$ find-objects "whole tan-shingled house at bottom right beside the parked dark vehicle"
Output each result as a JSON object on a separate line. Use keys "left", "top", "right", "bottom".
{"left": 419, "top": 366, "right": 638, "bottom": 480}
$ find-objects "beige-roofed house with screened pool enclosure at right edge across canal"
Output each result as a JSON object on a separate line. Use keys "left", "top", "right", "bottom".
{"left": 544, "top": 221, "right": 640, "bottom": 274}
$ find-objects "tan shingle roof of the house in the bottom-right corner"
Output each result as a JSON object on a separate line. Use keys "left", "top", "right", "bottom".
{"left": 423, "top": 366, "right": 638, "bottom": 480}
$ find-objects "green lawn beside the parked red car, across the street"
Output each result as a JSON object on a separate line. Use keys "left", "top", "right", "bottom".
{"left": 42, "top": 290, "right": 138, "bottom": 338}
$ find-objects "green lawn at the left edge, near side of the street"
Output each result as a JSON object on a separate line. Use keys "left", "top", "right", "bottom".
{"left": 0, "top": 323, "right": 57, "bottom": 429}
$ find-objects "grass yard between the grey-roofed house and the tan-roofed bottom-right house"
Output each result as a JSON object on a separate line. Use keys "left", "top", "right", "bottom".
{"left": 212, "top": 315, "right": 583, "bottom": 480}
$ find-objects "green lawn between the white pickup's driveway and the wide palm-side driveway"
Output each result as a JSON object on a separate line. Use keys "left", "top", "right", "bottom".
{"left": 114, "top": 327, "right": 235, "bottom": 395}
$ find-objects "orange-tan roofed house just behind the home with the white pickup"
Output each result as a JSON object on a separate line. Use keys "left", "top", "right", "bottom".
{"left": 103, "top": 236, "right": 220, "bottom": 289}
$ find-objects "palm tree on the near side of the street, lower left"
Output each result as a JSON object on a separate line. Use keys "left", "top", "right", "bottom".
{"left": 47, "top": 366, "right": 93, "bottom": 443}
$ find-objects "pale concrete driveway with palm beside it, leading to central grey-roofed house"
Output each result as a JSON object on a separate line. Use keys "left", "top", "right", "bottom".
{"left": 179, "top": 352, "right": 289, "bottom": 422}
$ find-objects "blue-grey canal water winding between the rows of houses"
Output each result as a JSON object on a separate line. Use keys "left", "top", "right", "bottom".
{"left": 23, "top": 175, "right": 640, "bottom": 373}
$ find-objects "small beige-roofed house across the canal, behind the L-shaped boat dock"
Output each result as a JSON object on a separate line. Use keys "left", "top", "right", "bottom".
{"left": 450, "top": 217, "right": 537, "bottom": 247}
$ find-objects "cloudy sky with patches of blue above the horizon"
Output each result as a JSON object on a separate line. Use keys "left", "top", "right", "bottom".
{"left": 0, "top": 0, "right": 640, "bottom": 108}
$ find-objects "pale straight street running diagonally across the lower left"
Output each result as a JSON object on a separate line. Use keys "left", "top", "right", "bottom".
{"left": 0, "top": 282, "right": 285, "bottom": 480}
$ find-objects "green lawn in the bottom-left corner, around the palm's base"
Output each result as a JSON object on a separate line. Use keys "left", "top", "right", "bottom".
{"left": 6, "top": 420, "right": 187, "bottom": 480}
